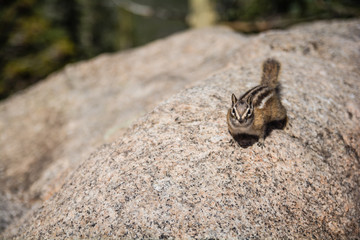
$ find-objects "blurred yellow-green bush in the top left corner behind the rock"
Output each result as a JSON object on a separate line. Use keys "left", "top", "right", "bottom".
{"left": 0, "top": 0, "right": 75, "bottom": 98}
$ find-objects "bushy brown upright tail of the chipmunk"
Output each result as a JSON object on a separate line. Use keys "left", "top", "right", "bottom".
{"left": 261, "top": 58, "right": 281, "bottom": 88}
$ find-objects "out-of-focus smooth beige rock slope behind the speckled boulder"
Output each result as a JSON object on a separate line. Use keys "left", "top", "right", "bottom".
{"left": 0, "top": 26, "right": 236, "bottom": 232}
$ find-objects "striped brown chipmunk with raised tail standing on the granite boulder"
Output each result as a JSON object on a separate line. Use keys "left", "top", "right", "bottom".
{"left": 227, "top": 58, "right": 286, "bottom": 147}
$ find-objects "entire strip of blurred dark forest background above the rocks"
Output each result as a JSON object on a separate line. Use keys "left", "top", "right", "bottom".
{"left": 0, "top": 0, "right": 360, "bottom": 99}
